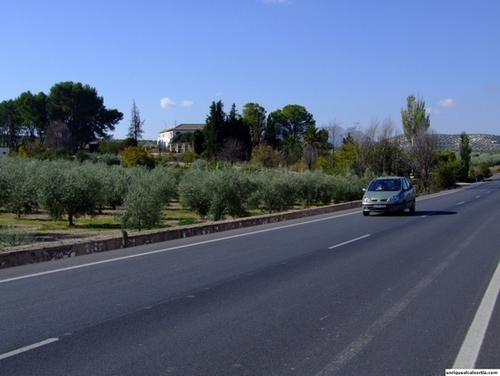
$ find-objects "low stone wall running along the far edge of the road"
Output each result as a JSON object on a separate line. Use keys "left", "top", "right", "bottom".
{"left": 0, "top": 201, "right": 361, "bottom": 269}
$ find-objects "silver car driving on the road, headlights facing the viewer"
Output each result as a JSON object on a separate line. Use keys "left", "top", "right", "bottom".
{"left": 361, "top": 176, "right": 415, "bottom": 216}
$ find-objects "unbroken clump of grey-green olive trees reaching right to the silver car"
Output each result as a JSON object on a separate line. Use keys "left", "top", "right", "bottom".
{"left": 179, "top": 163, "right": 373, "bottom": 220}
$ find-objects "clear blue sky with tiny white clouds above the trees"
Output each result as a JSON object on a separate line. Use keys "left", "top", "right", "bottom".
{"left": 0, "top": 0, "right": 500, "bottom": 139}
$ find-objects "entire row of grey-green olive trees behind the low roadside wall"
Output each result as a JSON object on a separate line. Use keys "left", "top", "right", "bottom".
{"left": 0, "top": 157, "right": 372, "bottom": 229}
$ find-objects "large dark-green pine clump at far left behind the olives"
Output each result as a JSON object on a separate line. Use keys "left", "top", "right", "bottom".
{"left": 0, "top": 81, "right": 123, "bottom": 152}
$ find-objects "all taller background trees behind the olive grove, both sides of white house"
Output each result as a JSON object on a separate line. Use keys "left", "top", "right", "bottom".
{"left": 0, "top": 82, "right": 480, "bottom": 192}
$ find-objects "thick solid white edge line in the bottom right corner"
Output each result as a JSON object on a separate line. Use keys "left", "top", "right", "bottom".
{"left": 452, "top": 263, "right": 500, "bottom": 369}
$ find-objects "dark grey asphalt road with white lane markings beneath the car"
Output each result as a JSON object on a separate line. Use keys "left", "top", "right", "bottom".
{"left": 0, "top": 180, "right": 500, "bottom": 376}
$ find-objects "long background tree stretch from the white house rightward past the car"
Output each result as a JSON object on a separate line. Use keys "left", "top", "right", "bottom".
{"left": 186, "top": 95, "right": 474, "bottom": 193}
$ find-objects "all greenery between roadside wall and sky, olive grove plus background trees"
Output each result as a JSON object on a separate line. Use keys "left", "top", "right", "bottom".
{"left": 0, "top": 86, "right": 500, "bottom": 247}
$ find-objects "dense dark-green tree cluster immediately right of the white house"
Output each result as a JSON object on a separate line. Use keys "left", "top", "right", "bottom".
{"left": 189, "top": 101, "right": 329, "bottom": 167}
